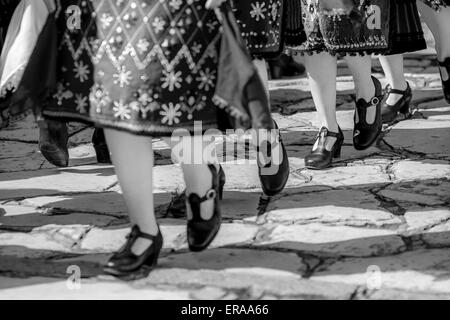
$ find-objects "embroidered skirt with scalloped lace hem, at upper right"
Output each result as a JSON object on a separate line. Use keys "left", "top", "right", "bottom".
{"left": 288, "top": 0, "right": 390, "bottom": 55}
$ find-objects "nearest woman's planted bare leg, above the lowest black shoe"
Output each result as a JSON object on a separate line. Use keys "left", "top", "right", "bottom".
{"left": 105, "top": 129, "right": 158, "bottom": 255}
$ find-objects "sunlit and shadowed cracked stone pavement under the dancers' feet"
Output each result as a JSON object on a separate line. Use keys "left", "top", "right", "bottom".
{"left": 0, "top": 53, "right": 450, "bottom": 299}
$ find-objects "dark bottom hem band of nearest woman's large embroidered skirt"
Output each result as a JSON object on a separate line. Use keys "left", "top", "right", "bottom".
{"left": 43, "top": 110, "right": 221, "bottom": 137}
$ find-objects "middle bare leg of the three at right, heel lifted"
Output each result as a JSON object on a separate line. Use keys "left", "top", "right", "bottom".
{"left": 345, "top": 56, "right": 377, "bottom": 124}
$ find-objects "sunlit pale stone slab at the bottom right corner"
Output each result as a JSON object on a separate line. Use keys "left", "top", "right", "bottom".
{"left": 311, "top": 249, "right": 450, "bottom": 293}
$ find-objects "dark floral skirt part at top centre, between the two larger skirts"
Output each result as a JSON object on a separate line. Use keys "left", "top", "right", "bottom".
{"left": 232, "top": 0, "right": 285, "bottom": 59}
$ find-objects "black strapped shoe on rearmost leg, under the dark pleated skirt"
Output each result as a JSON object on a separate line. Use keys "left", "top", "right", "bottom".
{"left": 381, "top": 82, "right": 412, "bottom": 124}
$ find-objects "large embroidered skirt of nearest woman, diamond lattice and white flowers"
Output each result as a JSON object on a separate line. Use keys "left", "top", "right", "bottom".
{"left": 15, "top": 0, "right": 270, "bottom": 136}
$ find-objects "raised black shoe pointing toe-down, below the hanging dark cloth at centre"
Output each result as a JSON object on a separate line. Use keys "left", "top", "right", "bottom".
{"left": 258, "top": 121, "right": 290, "bottom": 197}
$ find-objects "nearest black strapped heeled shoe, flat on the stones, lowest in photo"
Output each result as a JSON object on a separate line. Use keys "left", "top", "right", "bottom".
{"left": 103, "top": 226, "right": 163, "bottom": 277}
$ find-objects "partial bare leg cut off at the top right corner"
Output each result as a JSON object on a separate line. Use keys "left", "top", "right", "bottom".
{"left": 417, "top": 1, "right": 450, "bottom": 61}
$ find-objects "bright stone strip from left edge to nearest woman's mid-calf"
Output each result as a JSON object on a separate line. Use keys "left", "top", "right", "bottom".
{"left": 0, "top": 165, "right": 116, "bottom": 200}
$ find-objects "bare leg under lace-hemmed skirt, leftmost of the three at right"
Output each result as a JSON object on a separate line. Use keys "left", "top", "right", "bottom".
{"left": 305, "top": 52, "right": 339, "bottom": 151}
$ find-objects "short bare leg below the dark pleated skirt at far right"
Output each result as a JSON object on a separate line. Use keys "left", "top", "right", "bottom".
{"left": 379, "top": 54, "right": 408, "bottom": 106}
